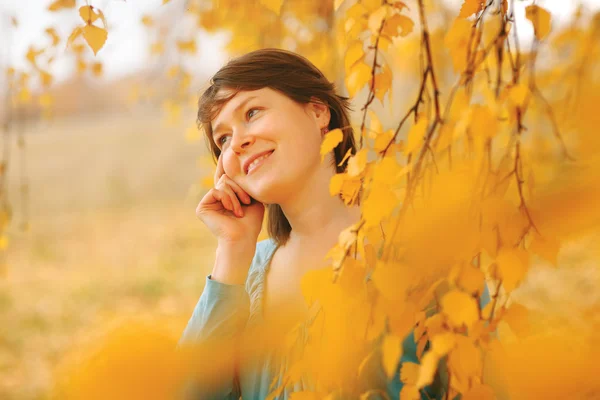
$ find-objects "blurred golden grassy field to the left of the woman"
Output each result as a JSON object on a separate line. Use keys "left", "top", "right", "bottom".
{"left": 0, "top": 110, "right": 214, "bottom": 400}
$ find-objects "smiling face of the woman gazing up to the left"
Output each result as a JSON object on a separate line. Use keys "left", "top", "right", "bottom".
{"left": 212, "top": 88, "right": 330, "bottom": 204}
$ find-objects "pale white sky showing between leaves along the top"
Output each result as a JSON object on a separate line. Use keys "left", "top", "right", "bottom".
{"left": 0, "top": 0, "right": 600, "bottom": 88}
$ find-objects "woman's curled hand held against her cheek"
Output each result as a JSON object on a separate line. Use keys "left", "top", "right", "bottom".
{"left": 196, "top": 156, "right": 264, "bottom": 248}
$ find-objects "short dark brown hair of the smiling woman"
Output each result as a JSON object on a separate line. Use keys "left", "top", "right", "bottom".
{"left": 198, "top": 48, "right": 356, "bottom": 244}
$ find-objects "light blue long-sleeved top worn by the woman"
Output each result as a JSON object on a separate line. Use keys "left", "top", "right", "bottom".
{"left": 179, "top": 239, "right": 490, "bottom": 400}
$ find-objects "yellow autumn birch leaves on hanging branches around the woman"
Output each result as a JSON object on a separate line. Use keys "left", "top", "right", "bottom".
{"left": 4, "top": 0, "right": 600, "bottom": 400}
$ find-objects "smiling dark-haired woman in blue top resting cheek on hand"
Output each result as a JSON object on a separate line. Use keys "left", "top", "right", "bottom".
{"left": 180, "top": 49, "right": 488, "bottom": 400}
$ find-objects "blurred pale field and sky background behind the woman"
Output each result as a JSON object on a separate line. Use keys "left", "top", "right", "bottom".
{"left": 0, "top": 0, "right": 600, "bottom": 399}
